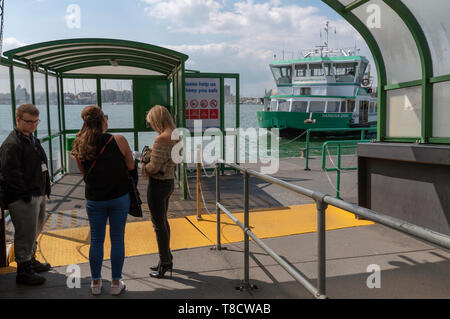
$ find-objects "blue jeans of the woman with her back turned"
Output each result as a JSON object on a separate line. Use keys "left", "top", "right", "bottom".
{"left": 86, "top": 193, "right": 130, "bottom": 280}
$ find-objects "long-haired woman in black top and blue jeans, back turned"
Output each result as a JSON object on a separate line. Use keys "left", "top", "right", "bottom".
{"left": 71, "top": 105, "right": 137, "bottom": 295}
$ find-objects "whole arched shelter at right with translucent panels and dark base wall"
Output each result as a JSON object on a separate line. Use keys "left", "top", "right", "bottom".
{"left": 322, "top": 0, "right": 450, "bottom": 234}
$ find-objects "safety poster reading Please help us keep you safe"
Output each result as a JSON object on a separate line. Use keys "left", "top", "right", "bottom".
{"left": 185, "top": 78, "right": 220, "bottom": 132}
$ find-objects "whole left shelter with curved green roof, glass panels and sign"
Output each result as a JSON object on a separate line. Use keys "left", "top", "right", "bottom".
{"left": 0, "top": 38, "right": 239, "bottom": 268}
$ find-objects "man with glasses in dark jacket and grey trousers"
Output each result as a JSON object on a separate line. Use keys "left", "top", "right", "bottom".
{"left": 0, "top": 104, "right": 50, "bottom": 285}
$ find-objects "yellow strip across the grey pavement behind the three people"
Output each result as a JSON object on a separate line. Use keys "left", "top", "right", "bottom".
{"left": 0, "top": 204, "right": 373, "bottom": 274}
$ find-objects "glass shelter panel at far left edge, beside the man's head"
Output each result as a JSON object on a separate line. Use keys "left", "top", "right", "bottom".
{"left": 0, "top": 65, "right": 13, "bottom": 144}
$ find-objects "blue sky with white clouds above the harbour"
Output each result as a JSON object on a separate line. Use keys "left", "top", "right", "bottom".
{"left": 3, "top": 0, "right": 374, "bottom": 97}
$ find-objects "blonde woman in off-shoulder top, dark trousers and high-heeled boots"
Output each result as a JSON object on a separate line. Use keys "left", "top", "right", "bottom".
{"left": 142, "top": 105, "right": 179, "bottom": 278}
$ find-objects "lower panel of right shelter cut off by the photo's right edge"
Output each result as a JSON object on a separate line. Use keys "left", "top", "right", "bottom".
{"left": 433, "top": 82, "right": 450, "bottom": 137}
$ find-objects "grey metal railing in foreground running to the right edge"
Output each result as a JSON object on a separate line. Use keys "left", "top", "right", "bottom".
{"left": 216, "top": 161, "right": 450, "bottom": 299}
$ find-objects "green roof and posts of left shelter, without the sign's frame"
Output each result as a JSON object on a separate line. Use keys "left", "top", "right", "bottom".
{"left": 0, "top": 38, "right": 188, "bottom": 188}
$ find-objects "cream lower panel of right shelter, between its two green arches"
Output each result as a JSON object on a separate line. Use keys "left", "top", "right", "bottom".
{"left": 386, "top": 86, "right": 422, "bottom": 137}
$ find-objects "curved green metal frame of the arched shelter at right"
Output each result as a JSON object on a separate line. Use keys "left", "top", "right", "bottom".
{"left": 322, "top": 0, "right": 450, "bottom": 144}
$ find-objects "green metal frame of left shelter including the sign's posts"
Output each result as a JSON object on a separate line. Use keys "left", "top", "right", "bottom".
{"left": 0, "top": 38, "right": 243, "bottom": 199}
